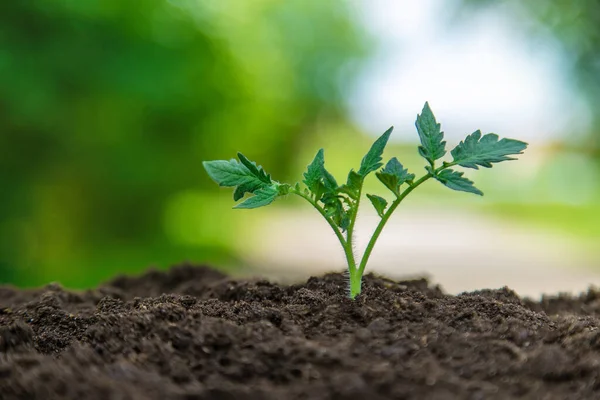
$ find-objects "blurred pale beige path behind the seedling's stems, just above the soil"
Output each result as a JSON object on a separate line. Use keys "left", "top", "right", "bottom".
{"left": 248, "top": 208, "right": 600, "bottom": 297}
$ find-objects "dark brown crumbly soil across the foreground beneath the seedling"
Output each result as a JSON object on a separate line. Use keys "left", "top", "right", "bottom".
{"left": 0, "top": 265, "right": 600, "bottom": 400}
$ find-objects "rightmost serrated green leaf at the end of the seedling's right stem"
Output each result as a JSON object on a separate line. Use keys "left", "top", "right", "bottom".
{"left": 450, "top": 130, "right": 527, "bottom": 169}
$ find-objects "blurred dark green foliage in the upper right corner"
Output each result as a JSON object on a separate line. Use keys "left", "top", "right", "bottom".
{"left": 461, "top": 0, "right": 600, "bottom": 148}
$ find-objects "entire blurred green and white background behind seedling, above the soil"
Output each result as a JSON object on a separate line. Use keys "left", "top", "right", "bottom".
{"left": 0, "top": 0, "right": 600, "bottom": 294}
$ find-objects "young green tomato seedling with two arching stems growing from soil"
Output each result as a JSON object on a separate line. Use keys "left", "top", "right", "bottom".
{"left": 203, "top": 103, "right": 527, "bottom": 298}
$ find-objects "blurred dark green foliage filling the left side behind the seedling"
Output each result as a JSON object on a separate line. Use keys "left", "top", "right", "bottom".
{"left": 0, "top": 0, "right": 367, "bottom": 287}
